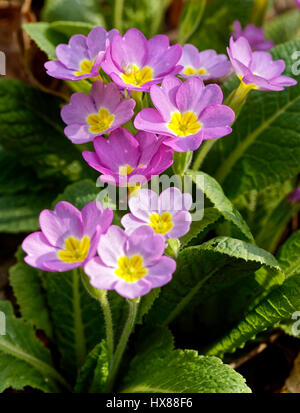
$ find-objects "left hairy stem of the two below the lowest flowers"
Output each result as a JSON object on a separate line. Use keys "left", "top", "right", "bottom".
{"left": 81, "top": 271, "right": 114, "bottom": 366}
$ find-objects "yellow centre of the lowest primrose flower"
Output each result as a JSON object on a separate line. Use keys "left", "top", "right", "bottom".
{"left": 115, "top": 255, "right": 148, "bottom": 283}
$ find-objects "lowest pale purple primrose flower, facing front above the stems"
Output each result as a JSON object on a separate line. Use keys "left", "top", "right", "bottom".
{"left": 84, "top": 225, "right": 176, "bottom": 299}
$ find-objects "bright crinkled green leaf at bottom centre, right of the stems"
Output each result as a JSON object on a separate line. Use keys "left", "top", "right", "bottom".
{"left": 120, "top": 330, "right": 250, "bottom": 393}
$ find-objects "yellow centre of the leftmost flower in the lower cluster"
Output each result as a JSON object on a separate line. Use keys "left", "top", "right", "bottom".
{"left": 57, "top": 235, "right": 90, "bottom": 263}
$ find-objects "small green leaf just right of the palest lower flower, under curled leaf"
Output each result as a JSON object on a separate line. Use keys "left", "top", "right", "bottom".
{"left": 180, "top": 208, "right": 222, "bottom": 248}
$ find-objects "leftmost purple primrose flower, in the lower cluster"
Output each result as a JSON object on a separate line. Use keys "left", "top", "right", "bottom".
{"left": 22, "top": 201, "right": 113, "bottom": 272}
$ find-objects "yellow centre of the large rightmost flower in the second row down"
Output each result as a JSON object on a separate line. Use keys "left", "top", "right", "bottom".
{"left": 168, "top": 111, "right": 202, "bottom": 136}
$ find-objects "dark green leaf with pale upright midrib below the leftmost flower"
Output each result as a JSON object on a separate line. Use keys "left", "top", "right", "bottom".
{"left": 45, "top": 269, "right": 105, "bottom": 381}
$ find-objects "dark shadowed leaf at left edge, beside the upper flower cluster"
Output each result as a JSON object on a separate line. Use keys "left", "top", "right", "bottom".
{"left": 0, "top": 79, "right": 90, "bottom": 182}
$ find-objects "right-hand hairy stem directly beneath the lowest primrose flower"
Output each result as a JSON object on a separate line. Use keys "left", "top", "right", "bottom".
{"left": 107, "top": 299, "right": 140, "bottom": 392}
